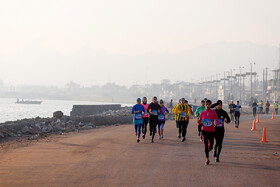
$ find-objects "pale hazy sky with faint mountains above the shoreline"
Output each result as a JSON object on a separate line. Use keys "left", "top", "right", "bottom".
{"left": 0, "top": 0, "right": 280, "bottom": 86}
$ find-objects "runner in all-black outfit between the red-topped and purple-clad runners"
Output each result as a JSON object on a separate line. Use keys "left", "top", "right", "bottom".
{"left": 148, "top": 97, "right": 160, "bottom": 143}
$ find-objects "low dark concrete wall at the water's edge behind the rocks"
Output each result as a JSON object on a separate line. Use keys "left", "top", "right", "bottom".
{"left": 70, "top": 104, "right": 121, "bottom": 117}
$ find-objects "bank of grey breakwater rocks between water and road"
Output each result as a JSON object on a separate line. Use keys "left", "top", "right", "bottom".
{"left": 0, "top": 107, "right": 133, "bottom": 142}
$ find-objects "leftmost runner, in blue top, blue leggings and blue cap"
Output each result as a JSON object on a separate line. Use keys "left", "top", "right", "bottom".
{"left": 131, "top": 98, "right": 145, "bottom": 142}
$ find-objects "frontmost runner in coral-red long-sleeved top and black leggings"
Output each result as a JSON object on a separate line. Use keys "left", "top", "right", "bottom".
{"left": 197, "top": 100, "right": 220, "bottom": 165}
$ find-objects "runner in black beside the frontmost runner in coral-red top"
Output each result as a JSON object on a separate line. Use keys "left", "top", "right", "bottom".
{"left": 213, "top": 100, "right": 230, "bottom": 162}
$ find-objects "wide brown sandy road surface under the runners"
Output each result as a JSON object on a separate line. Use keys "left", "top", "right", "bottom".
{"left": 0, "top": 116, "right": 280, "bottom": 186}
